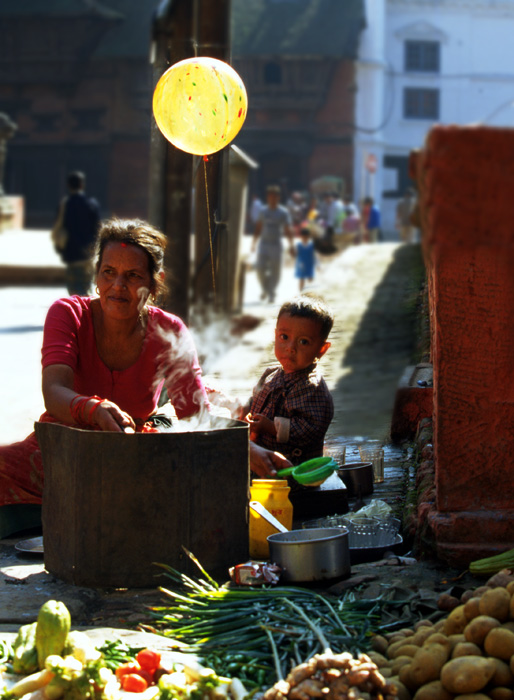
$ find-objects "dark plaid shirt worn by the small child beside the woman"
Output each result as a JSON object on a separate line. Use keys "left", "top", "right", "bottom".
{"left": 250, "top": 365, "right": 334, "bottom": 464}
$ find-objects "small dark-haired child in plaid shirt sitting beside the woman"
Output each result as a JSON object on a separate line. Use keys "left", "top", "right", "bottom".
{"left": 243, "top": 296, "right": 334, "bottom": 465}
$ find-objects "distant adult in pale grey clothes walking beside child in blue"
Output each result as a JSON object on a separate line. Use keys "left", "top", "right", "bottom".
{"left": 252, "top": 185, "right": 295, "bottom": 302}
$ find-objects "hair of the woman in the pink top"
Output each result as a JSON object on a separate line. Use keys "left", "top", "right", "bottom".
{"left": 95, "top": 217, "right": 167, "bottom": 296}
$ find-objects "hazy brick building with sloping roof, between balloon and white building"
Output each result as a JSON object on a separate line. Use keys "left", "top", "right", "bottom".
{"left": 232, "top": 0, "right": 365, "bottom": 200}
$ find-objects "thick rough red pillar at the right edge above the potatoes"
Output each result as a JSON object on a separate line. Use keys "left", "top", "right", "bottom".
{"left": 411, "top": 126, "right": 514, "bottom": 565}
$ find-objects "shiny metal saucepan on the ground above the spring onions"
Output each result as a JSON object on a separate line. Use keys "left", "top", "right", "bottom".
{"left": 267, "top": 527, "right": 351, "bottom": 582}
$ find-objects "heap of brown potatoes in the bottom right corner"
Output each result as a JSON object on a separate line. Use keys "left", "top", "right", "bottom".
{"left": 369, "top": 571, "right": 514, "bottom": 700}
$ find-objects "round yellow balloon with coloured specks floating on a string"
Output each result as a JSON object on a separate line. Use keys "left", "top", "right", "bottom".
{"left": 153, "top": 56, "right": 248, "bottom": 155}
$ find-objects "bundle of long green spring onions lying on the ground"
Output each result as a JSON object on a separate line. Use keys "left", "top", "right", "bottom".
{"left": 146, "top": 565, "right": 381, "bottom": 689}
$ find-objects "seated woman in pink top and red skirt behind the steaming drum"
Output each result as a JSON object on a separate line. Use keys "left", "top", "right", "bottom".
{"left": 0, "top": 219, "right": 209, "bottom": 505}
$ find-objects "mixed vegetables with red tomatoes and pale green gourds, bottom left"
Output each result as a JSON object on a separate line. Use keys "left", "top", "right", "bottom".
{"left": 0, "top": 600, "right": 247, "bottom": 700}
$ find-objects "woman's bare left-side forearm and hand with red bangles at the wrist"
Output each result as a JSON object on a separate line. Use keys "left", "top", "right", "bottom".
{"left": 43, "top": 365, "right": 136, "bottom": 432}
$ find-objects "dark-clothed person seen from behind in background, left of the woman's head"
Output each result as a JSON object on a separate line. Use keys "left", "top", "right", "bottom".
{"left": 52, "top": 171, "right": 100, "bottom": 296}
